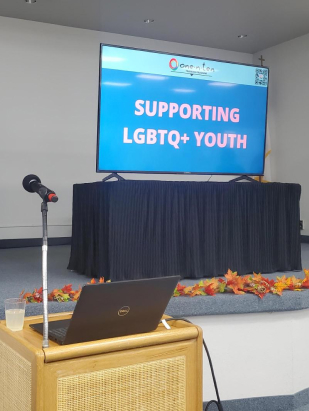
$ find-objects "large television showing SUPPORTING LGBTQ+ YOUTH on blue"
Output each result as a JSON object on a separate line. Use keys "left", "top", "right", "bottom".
{"left": 97, "top": 44, "right": 268, "bottom": 175}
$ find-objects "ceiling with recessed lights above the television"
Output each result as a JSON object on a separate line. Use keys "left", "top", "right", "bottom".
{"left": 0, "top": 0, "right": 309, "bottom": 53}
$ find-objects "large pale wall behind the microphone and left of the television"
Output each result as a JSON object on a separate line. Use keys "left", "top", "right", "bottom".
{"left": 0, "top": 17, "right": 252, "bottom": 238}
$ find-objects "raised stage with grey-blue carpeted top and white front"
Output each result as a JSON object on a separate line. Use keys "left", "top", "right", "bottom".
{"left": 0, "top": 244, "right": 309, "bottom": 411}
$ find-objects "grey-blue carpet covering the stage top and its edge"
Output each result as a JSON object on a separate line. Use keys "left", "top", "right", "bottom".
{"left": 0, "top": 244, "right": 309, "bottom": 319}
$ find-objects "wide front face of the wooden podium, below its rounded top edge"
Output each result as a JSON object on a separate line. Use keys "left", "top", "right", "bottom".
{"left": 44, "top": 341, "right": 201, "bottom": 411}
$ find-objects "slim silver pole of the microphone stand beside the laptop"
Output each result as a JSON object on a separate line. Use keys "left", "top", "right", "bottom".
{"left": 41, "top": 201, "right": 49, "bottom": 348}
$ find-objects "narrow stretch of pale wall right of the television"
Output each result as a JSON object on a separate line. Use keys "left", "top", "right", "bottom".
{"left": 254, "top": 35, "right": 309, "bottom": 235}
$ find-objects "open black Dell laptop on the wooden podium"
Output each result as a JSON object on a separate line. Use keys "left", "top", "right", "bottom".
{"left": 30, "top": 276, "right": 180, "bottom": 345}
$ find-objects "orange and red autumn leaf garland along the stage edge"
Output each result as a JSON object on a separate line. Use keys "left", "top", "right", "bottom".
{"left": 20, "top": 270, "right": 309, "bottom": 303}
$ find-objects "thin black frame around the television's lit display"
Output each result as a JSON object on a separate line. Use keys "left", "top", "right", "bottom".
{"left": 96, "top": 43, "right": 269, "bottom": 176}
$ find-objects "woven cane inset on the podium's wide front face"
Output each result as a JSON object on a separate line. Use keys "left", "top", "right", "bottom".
{"left": 58, "top": 356, "right": 186, "bottom": 411}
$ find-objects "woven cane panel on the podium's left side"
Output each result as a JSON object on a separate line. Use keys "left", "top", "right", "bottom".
{"left": 0, "top": 341, "right": 31, "bottom": 411}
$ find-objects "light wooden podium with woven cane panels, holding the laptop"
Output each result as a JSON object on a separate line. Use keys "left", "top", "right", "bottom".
{"left": 0, "top": 313, "right": 203, "bottom": 411}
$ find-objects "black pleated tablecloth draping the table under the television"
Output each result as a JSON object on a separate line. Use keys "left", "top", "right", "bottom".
{"left": 68, "top": 181, "right": 301, "bottom": 281}
